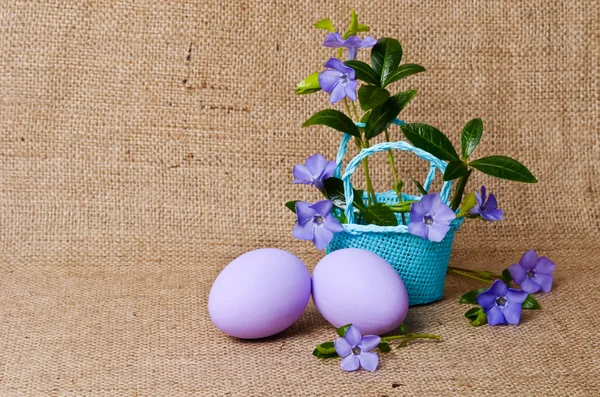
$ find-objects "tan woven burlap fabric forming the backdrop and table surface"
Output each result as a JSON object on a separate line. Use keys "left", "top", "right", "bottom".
{"left": 0, "top": 0, "right": 600, "bottom": 396}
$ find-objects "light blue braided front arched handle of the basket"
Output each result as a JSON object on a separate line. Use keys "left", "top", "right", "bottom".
{"left": 342, "top": 140, "right": 452, "bottom": 223}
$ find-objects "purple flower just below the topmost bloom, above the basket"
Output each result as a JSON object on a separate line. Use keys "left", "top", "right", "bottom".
{"left": 319, "top": 58, "right": 358, "bottom": 103}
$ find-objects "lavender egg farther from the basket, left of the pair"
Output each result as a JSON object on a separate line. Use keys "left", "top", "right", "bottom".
{"left": 208, "top": 248, "right": 311, "bottom": 339}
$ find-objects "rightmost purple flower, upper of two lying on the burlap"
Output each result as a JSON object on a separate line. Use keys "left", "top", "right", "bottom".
{"left": 508, "top": 250, "right": 556, "bottom": 294}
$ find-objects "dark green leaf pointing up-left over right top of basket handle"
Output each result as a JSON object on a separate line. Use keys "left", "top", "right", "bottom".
{"left": 400, "top": 123, "right": 459, "bottom": 161}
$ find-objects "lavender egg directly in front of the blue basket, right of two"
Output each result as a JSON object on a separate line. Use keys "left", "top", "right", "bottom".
{"left": 312, "top": 248, "right": 408, "bottom": 335}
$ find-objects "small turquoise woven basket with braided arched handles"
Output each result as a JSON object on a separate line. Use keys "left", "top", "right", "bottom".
{"left": 327, "top": 120, "right": 463, "bottom": 306}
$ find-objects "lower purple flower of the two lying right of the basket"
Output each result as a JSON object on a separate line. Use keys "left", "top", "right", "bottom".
{"left": 477, "top": 280, "right": 527, "bottom": 325}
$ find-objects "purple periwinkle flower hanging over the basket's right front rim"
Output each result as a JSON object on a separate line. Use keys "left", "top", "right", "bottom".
{"left": 408, "top": 193, "right": 456, "bottom": 242}
